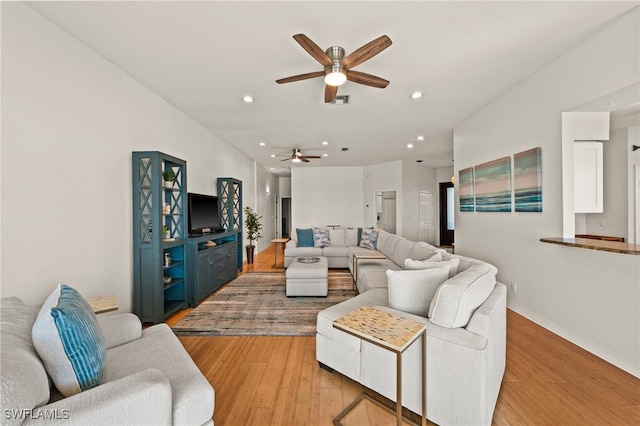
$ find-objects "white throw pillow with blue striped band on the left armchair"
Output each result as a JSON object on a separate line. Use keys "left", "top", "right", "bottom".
{"left": 31, "top": 284, "right": 107, "bottom": 396}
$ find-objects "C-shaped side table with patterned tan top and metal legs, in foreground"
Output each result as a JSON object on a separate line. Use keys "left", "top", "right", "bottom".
{"left": 333, "top": 306, "right": 427, "bottom": 426}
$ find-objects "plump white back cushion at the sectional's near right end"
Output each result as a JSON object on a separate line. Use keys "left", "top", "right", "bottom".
{"left": 429, "top": 263, "right": 496, "bottom": 328}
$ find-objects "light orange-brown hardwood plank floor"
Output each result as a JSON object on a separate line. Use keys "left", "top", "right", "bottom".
{"left": 167, "top": 246, "right": 640, "bottom": 426}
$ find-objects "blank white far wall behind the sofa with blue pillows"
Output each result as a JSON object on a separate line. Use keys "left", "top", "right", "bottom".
{"left": 291, "top": 167, "right": 362, "bottom": 230}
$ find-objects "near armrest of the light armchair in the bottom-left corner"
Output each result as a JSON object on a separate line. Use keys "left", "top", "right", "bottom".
{"left": 23, "top": 368, "right": 173, "bottom": 426}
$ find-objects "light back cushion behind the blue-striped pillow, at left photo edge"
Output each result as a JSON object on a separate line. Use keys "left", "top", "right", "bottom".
{"left": 0, "top": 297, "right": 50, "bottom": 425}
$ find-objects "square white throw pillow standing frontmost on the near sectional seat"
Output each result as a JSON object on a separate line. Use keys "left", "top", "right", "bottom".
{"left": 387, "top": 266, "right": 449, "bottom": 318}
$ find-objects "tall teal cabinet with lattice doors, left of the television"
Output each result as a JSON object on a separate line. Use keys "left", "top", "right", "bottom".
{"left": 132, "top": 151, "right": 188, "bottom": 323}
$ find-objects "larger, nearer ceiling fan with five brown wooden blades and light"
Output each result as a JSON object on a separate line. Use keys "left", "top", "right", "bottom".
{"left": 276, "top": 34, "right": 391, "bottom": 103}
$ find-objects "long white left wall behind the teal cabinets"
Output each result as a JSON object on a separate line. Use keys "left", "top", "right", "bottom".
{"left": 0, "top": 2, "right": 262, "bottom": 311}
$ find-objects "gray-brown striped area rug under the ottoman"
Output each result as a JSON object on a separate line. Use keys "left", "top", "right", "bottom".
{"left": 172, "top": 270, "right": 355, "bottom": 336}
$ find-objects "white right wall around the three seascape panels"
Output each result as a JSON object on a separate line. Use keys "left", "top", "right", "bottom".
{"left": 454, "top": 8, "right": 640, "bottom": 376}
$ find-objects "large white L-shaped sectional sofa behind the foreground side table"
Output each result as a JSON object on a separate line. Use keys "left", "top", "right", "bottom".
{"left": 304, "top": 231, "right": 506, "bottom": 425}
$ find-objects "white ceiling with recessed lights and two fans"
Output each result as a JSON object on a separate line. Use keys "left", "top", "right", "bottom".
{"left": 28, "top": 1, "right": 638, "bottom": 175}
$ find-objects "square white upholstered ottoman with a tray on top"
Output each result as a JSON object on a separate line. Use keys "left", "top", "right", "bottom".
{"left": 286, "top": 256, "right": 329, "bottom": 297}
